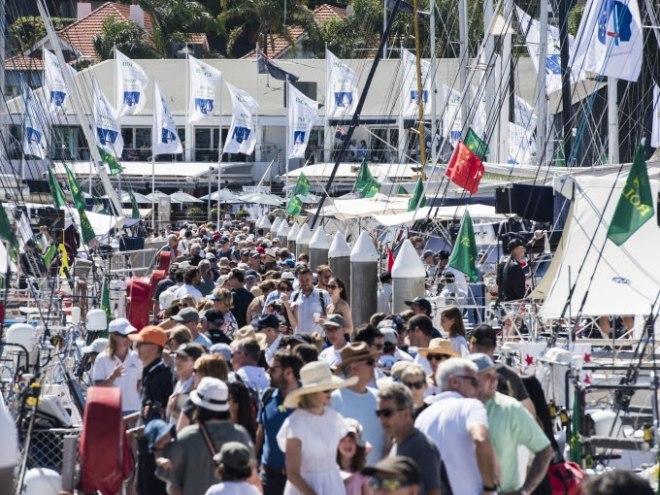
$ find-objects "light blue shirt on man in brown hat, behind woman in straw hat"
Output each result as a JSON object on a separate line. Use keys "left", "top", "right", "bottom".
{"left": 332, "top": 387, "right": 385, "bottom": 464}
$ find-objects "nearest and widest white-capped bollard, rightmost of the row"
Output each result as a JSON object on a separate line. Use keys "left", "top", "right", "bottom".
{"left": 392, "top": 239, "right": 426, "bottom": 314}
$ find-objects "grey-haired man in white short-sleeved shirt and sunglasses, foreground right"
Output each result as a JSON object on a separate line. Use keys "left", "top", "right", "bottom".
{"left": 415, "top": 358, "right": 498, "bottom": 495}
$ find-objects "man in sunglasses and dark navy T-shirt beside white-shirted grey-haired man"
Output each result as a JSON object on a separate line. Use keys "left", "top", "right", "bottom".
{"left": 376, "top": 383, "right": 441, "bottom": 495}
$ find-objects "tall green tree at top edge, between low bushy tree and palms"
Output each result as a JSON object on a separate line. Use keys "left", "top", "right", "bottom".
{"left": 122, "top": 0, "right": 218, "bottom": 58}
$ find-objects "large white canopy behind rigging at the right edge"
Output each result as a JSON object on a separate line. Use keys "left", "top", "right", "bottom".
{"left": 541, "top": 172, "right": 660, "bottom": 318}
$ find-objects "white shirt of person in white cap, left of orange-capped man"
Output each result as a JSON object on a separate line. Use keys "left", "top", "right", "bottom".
{"left": 92, "top": 350, "right": 142, "bottom": 412}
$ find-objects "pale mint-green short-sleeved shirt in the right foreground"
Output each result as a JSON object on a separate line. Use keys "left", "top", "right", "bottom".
{"left": 486, "top": 392, "right": 550, "bottom": 492}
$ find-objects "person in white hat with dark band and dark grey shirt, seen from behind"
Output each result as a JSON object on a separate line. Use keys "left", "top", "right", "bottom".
{"left": 156, "top": 377, "right": 254, "bottom": 495}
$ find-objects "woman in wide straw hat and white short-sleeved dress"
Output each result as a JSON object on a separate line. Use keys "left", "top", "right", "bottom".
{"left": 277, "top": 361, "right": 357, "bottom": 495}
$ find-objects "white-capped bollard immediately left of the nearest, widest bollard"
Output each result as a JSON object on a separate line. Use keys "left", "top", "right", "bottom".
{"left": 350, "top": 230, "right": 378, "bottom": 328}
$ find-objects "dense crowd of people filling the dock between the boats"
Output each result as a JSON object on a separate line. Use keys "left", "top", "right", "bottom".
{"left": 85, "top": 218, "right": 656, "bottom": 495}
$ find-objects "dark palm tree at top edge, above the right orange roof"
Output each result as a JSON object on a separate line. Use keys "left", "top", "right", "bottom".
{"left": 218, "top": 0, "right": 316, "bottom": 54}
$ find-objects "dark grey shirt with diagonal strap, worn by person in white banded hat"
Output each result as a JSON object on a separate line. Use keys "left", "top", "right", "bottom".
{"left": 158, "top": 420, "right": 254, "bottom": 495}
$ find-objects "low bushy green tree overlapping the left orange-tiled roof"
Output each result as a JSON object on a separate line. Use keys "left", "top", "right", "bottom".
{"left": 93, "top": 16, "right": 156, "bottom": 60}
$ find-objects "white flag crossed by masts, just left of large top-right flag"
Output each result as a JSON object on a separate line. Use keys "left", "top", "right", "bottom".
{"left": 516, "top": 6, "right": 585, "bottom": 94}
